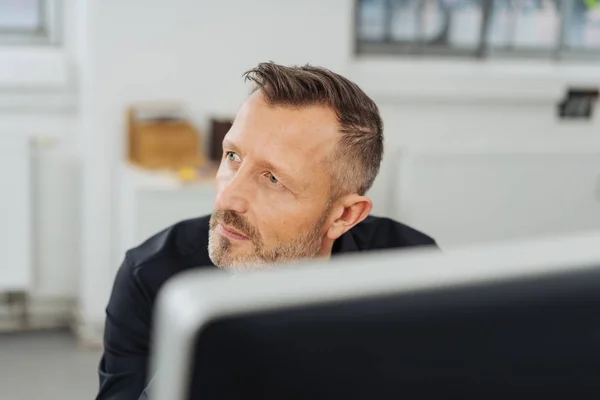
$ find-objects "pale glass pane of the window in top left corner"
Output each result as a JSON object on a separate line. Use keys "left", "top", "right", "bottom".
{"left": 0, "top": 0, "right": 41, "bottom": 31}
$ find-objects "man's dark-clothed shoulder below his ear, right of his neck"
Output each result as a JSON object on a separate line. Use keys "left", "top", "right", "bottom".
{"left": 350, "top": 216, "right": 436, "bottom": 250}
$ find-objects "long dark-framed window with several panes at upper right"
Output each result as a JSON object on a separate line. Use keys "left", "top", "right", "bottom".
{"left": 356, "top": 0, "right": 600, "bottom": 58}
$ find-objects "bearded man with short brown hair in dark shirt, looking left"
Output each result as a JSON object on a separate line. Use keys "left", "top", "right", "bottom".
{"left": 97, "top": 63, "right": 434, "bottom": 400}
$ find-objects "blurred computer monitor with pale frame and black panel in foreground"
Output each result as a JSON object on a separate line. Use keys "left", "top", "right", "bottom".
{"left": 149, "top": 233, "right": 600, "bottom": 400}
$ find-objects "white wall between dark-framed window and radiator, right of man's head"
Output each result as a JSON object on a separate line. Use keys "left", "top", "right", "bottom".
{"left": 348, "top": 57, "right": 600, "bottom": 215}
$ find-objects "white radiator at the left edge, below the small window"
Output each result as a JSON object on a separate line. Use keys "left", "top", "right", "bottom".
{"left": 0, "top": 135, "right": 33, "bottom": 293}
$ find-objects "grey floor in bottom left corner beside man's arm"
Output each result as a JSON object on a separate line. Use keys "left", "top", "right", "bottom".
{"left": 0, "top": 331, "right": 100, "bottom": 400}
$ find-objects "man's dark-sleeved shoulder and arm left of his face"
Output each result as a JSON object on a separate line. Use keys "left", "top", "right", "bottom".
{"left": 98, "top": 217, "right": 212, "bottom": 399}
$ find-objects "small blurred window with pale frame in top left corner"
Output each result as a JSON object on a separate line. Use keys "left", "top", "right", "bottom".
{"left": 0, "top": 0, "right": 59, "bottom": 45}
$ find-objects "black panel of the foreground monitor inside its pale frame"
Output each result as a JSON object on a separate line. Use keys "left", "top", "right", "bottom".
{"left": 187, "top": 269, "right": 600, "bottom": 400}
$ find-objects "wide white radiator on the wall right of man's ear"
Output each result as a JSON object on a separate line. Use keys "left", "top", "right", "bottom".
{"left": 390, "top": 145, "right": 600, "bottom": 246}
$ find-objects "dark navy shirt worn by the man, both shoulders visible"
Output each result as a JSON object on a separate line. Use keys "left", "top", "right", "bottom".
{"left": 96, "top": 216, "right": 435, "bottom": 400}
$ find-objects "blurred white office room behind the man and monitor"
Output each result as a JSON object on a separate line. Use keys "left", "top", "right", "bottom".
{"left": 0, "top": 0, "right": 600, "bottom": 399}
